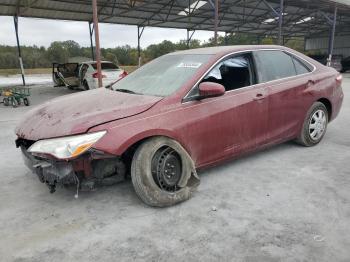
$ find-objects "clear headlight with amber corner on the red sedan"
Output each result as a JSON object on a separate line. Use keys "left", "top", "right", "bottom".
{"left": 28, "top": 131, "right": 107, "bottom": 159}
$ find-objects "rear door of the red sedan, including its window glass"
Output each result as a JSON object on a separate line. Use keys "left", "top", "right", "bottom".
{"left": 254, "top": 50, "right": 313, "bottom": 142}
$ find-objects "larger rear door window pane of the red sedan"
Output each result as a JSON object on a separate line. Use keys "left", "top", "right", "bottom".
{"left": 254, "top": 50, "right": 297, "bottom": 83}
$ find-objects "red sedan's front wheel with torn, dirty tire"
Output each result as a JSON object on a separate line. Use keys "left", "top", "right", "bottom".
{"left": 131, "top": 137, "right": 199, "bottom": 207}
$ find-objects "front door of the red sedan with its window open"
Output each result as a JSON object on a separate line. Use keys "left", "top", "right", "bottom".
{"left": 183, "top": 53, "right": 268, "bottom": 166}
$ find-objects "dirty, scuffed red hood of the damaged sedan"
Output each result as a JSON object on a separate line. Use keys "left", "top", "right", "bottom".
{"left": 16, "top": 88, "right": 162, "bottom": 140}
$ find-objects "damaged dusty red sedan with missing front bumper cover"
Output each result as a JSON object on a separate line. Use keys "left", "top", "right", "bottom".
{"left": 16, "top": 46, "right": 343, "bottom": 206}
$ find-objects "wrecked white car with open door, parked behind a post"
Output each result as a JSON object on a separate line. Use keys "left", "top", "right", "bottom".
{"left": 52, "top": 61, "right": 127, "bottom": 90}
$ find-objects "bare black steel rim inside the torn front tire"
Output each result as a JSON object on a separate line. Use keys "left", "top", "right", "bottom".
{"left": 151, "top": 146, "right": 182, "bottom": 192}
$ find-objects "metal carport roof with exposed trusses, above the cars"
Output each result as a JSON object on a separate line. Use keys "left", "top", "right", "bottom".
{"left": 0, "top": 0, "right": 350, "bottom": 37}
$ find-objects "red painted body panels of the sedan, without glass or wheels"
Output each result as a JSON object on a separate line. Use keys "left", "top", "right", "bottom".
{"left": 16, "top": 46, "right": 343, "bottom": 167}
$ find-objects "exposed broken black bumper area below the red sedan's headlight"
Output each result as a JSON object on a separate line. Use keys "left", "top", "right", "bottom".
{"left": 16, "top": 139, "right": 126, "bottom": 193}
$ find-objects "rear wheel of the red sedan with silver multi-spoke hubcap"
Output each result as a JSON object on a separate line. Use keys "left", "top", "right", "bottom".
{"left": 296, "top": 102, "right": 328, "bottom": 146}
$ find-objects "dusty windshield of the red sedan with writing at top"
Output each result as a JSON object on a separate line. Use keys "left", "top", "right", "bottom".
{"left": 112, "top": 54, "right": 211, "bottom": 96}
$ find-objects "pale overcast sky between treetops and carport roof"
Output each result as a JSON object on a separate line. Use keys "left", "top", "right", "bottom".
{"left": 0, "top": 16, "right": 221, "bottom": 48}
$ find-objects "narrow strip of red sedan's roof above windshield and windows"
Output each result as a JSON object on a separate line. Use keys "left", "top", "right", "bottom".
{"left": 170, "top": 45, "right": 286, "bottom": 55}
